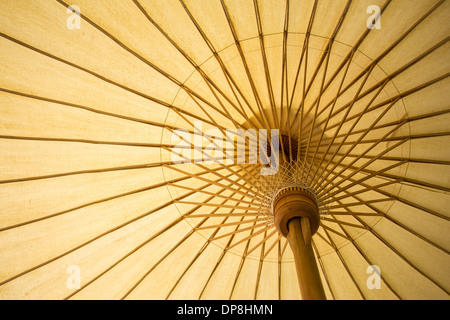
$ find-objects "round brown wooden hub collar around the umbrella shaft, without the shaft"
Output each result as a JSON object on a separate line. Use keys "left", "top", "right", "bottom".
{"left": 272, "top": 186, "right": 320, "bottom": 237}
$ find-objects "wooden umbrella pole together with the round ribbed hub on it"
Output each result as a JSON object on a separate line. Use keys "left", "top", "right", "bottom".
{"left": 272, "top": 187, "right": 326, "bottom": 300}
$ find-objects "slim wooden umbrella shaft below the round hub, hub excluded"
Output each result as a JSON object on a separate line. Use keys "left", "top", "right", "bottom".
{"left": 287, "top": 217, "right": 326, "bottom": 300}
